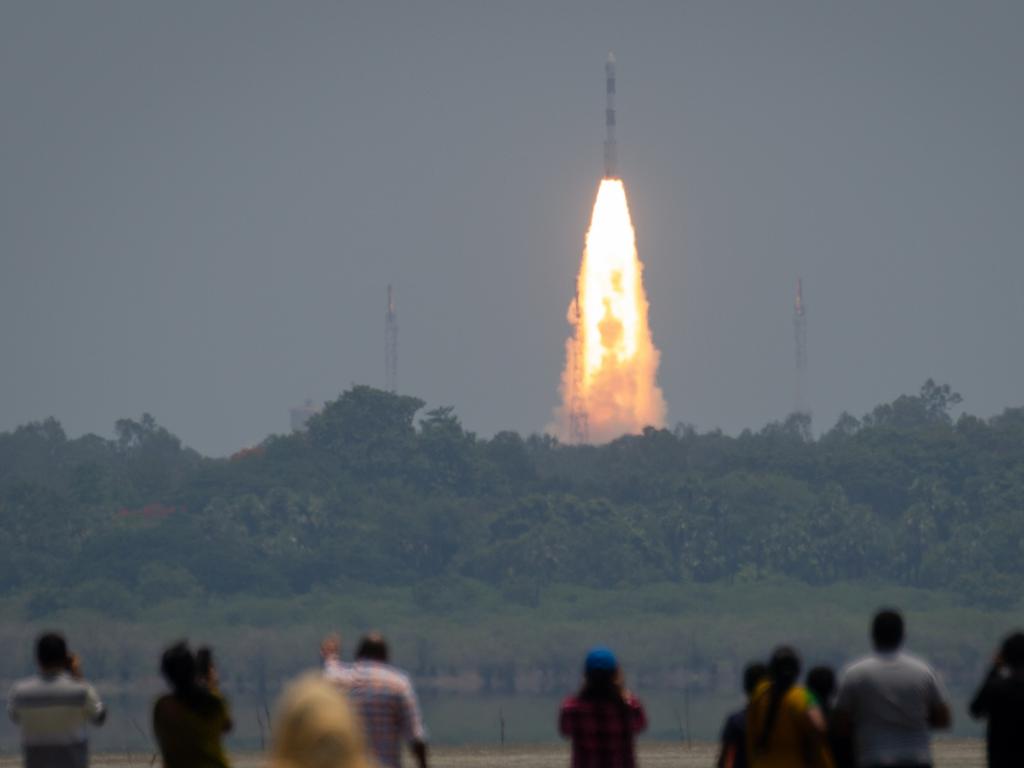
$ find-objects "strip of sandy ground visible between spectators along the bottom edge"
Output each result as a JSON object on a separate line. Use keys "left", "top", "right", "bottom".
{"left": 0, "top": 739, "right": 985, "bottom": 768}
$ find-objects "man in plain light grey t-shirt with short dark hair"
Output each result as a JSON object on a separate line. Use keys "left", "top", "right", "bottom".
{"left": 835, "top": 609, "right": 952, "bottom": 768}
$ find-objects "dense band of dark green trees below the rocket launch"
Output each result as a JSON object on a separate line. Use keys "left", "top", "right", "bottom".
{"left": 0, "top": 381, "right": 1024, "bottom": 615}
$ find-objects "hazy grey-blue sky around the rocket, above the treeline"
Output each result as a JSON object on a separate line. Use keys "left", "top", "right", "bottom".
{"left": 0, "top": 0, "right": 1024, "bottom": 454}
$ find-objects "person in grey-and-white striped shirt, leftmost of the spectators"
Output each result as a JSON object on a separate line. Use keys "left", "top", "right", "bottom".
{"left": 7, "top": 632, "right": 106, "bottom": 768}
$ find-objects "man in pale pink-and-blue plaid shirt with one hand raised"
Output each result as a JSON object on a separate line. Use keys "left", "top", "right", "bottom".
{"left": 321, "top": 633, "right": 427, "bottom": 768}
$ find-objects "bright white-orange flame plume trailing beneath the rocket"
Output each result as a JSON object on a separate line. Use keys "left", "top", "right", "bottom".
{"left": 553, "top": 178, "right": 666, "bottom": 442}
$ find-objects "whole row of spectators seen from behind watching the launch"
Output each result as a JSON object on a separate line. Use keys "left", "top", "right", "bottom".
{"left": 7, "top": 609, "right": 1024, "bottom": 768}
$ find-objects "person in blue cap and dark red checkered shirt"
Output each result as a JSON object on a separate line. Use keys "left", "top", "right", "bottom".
{"left": 558, "top": 648, "right": 647, "bottom": 768}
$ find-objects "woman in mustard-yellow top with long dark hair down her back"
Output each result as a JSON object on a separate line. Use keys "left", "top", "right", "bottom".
{"left": 746, "top": 646, "right": 836, "bottom": 768}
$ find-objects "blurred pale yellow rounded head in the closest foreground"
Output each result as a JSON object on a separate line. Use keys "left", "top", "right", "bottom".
{"left": 270, "top": 674, "right": 375, "bottom": 768}
